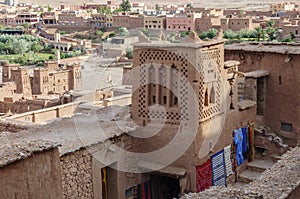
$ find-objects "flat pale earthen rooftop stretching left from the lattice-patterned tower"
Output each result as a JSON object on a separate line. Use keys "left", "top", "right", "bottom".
{"left": 0, "top": 106, "right": 135, "bottom": 158}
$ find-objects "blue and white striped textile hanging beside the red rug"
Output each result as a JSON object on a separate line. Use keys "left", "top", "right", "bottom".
{"left": 211, "top": 150, "right": 226, "bottom": 186}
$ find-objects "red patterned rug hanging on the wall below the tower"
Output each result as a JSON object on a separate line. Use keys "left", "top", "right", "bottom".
{"left": 196, "top": 159, "right": 212, "bottom": 192}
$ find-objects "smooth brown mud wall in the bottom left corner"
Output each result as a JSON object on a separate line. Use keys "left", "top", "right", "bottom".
{"left": 0, "top": 148, "right": 62, "bottom": 199}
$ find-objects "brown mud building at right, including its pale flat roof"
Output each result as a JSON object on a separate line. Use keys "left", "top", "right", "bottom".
{"left": 225, "top": 43, "right": 300, "bottom": 145}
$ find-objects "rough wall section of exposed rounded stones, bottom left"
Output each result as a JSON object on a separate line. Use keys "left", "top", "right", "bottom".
{"left": 60, "top": 149, "right": 94, "bottom": 198}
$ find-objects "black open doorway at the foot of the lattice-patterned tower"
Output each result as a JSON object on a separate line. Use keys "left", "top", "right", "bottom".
{"left": 151, "top": 175, "right": 180, "bottom": 199}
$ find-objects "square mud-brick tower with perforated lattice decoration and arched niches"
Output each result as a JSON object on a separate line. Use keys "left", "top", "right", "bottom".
{"left": 130, "top": 32, "right": 256, "bottom": 191}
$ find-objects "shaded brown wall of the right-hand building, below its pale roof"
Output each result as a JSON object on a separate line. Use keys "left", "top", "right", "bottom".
{"left": 225, "top": 49, "right": 300, "bottom": 145}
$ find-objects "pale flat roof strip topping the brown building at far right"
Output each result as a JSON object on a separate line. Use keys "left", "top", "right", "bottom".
{"left": 225, "top": 42, "right": 300, "bottom": 55}
